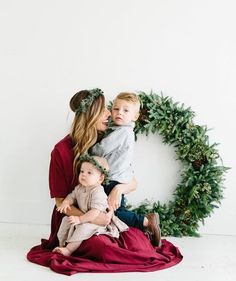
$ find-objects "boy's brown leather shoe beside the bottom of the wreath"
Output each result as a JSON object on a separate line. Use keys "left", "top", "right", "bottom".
{"left": 146, "top": 213, "right": 161, "bottom": 247}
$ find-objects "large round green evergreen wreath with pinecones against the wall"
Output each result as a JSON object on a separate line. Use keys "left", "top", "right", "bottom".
{"left": 129, "top": 92, "right": 228, "bottom": 237}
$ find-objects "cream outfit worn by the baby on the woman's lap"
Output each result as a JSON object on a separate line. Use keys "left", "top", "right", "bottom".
{"left": 57, "top": 184, "right": 128, "bottom": 244}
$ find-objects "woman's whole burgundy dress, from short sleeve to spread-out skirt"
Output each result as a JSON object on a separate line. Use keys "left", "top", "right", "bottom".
{"left": 27, "top": 136, "right": 182, "bottom": 275}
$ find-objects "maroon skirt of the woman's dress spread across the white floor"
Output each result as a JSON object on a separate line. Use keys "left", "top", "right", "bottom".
{"left": 27, "top": 227, "right": 182, "bottom": 275}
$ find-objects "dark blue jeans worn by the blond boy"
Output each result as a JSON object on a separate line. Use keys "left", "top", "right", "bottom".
{"left": 103, "top": 181, "right": 144, "bottom": 231}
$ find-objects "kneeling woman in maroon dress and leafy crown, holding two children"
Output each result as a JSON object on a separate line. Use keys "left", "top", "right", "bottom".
{"left": 27, "top": 89, "right": 182, "bottom": 275}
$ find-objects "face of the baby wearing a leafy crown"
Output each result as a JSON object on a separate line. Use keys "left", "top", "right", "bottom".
{"left": 79, "top": 162, "right": 104, "bottom": 187}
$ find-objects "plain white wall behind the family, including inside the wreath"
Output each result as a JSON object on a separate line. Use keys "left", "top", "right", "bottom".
{"left": 0, "top": 0, "right": 236, "bottom": 234}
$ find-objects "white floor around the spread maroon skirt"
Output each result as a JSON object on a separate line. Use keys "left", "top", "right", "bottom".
{"left": 0, "top": 223, "right": 236, "bottom": 281}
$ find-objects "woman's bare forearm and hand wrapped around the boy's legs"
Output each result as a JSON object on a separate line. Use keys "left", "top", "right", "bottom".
{"left": 107, "top": 178, "right": 137, "bottom": 210}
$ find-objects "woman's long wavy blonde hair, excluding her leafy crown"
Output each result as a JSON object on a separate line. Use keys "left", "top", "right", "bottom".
{"left": 70, "top": 90, "right": 105, "bottom": 177}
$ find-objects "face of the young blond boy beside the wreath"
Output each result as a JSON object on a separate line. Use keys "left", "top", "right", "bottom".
{"left": 111, "top": 99, "right": 139, "bottom": 126}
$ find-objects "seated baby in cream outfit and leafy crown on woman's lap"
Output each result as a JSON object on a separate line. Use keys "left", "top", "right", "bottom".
{"left": 53, "top": 154, "right": 128, "bottom": 256}
